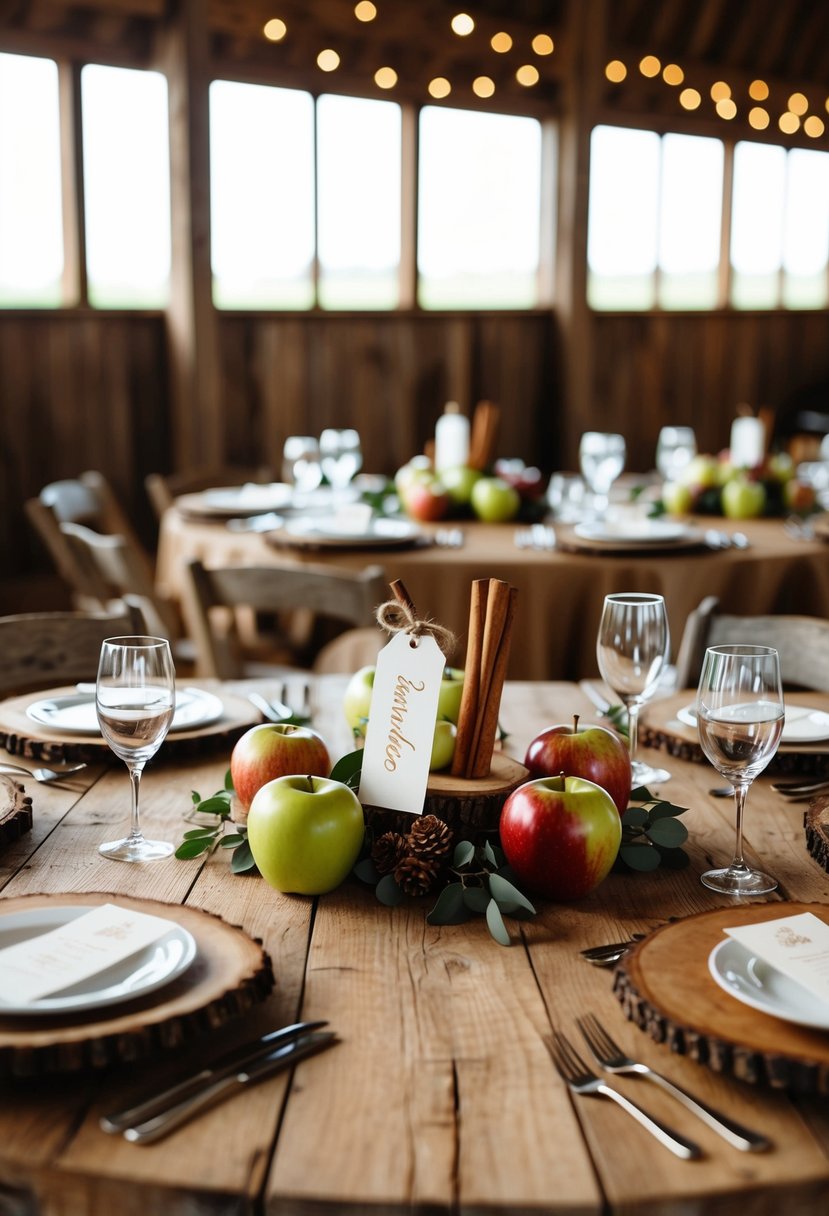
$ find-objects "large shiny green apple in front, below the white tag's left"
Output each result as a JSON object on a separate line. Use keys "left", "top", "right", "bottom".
{"left": 248, "top": 776, "right": 365, "bottom": 895}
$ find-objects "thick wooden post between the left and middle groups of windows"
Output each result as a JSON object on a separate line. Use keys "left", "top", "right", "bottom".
{"left": 156, "top": 0, "right": 225, "bottom": 469}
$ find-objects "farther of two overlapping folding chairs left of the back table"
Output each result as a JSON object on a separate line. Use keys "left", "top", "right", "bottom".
{"left": 26, "top": 471, "right": 153, "bottom": 612}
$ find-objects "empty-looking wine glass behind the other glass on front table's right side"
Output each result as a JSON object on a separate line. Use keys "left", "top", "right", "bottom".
{"left": 596, "top": 592, "right": 671, "bottom": 787}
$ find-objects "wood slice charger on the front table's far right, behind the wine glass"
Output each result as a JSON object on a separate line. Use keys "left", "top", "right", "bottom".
{"left": 639, "top": 688, "right": 829, "bottom": 777}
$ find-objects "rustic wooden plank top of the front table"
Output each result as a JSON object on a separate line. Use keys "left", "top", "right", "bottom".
{"left": 0, "top": 677, "right": 829, "bottom": 1216}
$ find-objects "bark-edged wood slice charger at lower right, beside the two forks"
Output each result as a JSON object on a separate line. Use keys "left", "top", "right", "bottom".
{"left": 614, "top": 903, "right": 829, "bottom": 1094}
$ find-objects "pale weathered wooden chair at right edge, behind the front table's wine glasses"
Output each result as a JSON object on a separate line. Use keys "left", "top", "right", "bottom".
{"left": 676, "top": 596, "right": 829, "bottom": 692}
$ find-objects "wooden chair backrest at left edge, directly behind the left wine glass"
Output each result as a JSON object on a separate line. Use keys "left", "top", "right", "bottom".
{"left": 0, "top": 603, "right": 147, "bottom": 697}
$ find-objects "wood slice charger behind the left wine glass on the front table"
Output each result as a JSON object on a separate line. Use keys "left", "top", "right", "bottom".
{"left": 0, "top": 687, "right": 257, "bottom": 764}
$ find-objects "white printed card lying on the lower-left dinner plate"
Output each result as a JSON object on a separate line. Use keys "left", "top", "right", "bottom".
{"left": 0, "top": 903, "right": 175, "bottom": 1007}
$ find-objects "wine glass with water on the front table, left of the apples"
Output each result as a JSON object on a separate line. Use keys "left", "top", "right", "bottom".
{"left": 95, "top": 636, "right": 175, "bottom": 861}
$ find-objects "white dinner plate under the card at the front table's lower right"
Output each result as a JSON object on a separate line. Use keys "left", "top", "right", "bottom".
{"left": 709, "top": 938, "right": 829, "bottom": 1030}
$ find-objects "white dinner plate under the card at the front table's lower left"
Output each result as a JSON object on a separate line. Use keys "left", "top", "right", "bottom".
{"left": 0, "top": 905, "right": 198, "bottom": 1017}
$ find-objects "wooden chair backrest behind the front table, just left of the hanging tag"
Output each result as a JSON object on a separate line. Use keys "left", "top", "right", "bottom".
{"left": 182, "top": 561, "right": 388, "bottom": 680}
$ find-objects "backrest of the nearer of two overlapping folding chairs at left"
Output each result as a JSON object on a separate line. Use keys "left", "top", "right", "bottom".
{"left": 58, "top": 523, "right": 181, "bottom": 640}
